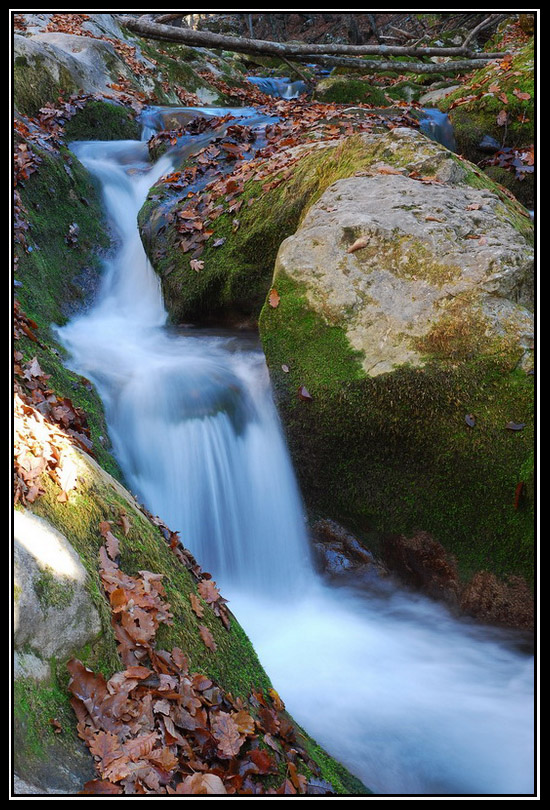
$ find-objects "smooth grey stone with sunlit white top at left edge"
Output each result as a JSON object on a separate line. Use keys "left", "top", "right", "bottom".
{"left": 14, "top": 510, "right": 101, "bottom": 664}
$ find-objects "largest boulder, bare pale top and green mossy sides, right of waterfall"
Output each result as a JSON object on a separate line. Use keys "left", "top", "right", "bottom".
{"left": 260, "top": 137, "right": 534, "bottom": 624}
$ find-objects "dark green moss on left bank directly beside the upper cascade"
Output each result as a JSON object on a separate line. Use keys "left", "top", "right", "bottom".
{"left": 16, "top": 142, "right": 120, "bottom": 477}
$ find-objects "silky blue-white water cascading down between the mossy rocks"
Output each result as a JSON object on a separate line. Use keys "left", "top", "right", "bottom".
{"left": 59, "top": 134, "right": 533, "bottom": 795}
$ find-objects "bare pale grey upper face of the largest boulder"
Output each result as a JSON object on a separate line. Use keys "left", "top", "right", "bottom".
{"left": 275, "top": 131, "right": 533, "bottom": 375}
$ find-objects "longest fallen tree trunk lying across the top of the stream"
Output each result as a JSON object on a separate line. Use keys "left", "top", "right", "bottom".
{"left": 119, "top": 15, "right": 505, "bottom": 61}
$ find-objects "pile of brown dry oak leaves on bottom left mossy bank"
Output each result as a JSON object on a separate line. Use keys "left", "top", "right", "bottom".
{"left": 68, "top": 521, "right": 333, "bottom": 795}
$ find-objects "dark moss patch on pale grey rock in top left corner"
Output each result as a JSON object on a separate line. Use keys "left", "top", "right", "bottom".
{"left": 13, "top": 56, "right": 80, "bottom": 116}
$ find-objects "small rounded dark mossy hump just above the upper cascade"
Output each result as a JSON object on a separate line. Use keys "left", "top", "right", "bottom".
{"left": 65, "top": 101, "right": 140, "bottom": 141}
